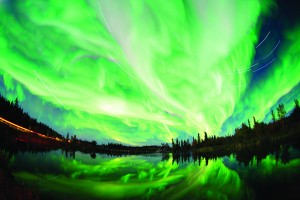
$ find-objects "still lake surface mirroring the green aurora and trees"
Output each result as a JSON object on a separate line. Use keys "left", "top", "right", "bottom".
{"left": 5, "top": 148, "right": 300, "bottom": 199}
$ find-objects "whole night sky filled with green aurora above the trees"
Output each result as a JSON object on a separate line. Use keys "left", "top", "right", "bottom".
{"left": 0, "top": 0, "right": 300, "bottom": 145}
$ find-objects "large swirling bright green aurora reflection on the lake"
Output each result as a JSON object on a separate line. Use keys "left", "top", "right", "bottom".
{"left": 14, "top": 152, "right": 245, "bottom": 199}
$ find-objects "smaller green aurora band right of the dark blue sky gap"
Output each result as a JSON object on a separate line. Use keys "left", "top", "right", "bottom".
{"left": 223, "top": 28, "right": 300, "bottom": 131}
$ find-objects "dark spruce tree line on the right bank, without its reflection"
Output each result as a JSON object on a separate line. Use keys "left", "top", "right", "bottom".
{"left": 172, "top": 99, "right": 300, "bottom": 154}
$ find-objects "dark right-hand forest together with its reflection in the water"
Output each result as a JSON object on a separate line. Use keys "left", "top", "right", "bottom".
{"left": 172, "top": 99, "right": 300, "bottom": 166}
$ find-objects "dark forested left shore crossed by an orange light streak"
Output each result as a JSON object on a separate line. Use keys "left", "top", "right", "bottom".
{"left": 0, "top": 95, "right": 170, "bottom": 155}
